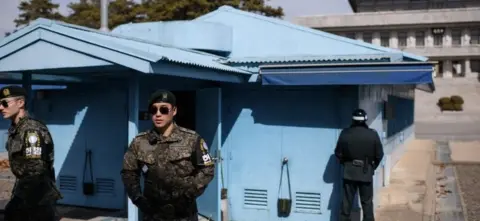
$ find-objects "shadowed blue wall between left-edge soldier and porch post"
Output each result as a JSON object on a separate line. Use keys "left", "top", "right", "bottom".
{"left": 37, "top": 85, "right": 128, "bottom": 209}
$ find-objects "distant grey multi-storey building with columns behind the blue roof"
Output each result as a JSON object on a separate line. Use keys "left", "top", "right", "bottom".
{"left": 294, "top": 0, "right": 480, "bottom": 78}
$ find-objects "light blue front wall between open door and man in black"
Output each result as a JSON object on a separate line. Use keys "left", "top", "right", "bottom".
{"left": 227, "top": 88, "right": 340, "bottom": 221}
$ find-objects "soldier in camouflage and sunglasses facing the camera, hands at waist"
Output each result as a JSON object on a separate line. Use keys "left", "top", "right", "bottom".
{"left": 121, "top": 90, "right": 214, "bottom": 221}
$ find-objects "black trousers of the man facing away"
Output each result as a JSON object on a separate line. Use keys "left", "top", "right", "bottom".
{"left": 340, "top": 179, "right": 375, "bottom": 221}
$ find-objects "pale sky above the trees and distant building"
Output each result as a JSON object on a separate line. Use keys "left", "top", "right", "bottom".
{"left": 0, "top": 0, "right": 352, "bottom": 36}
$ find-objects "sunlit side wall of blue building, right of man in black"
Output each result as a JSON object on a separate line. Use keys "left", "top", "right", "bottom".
{"left": 359, "top": 86, "right": 414, "bottom": 209}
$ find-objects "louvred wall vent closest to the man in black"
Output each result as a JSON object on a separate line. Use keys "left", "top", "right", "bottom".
{"left": 295, "top": 192, "right": 322, "bottom": 213}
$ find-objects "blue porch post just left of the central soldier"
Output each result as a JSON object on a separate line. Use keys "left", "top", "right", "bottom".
{"left": 127, "top": 73, "right": 140, "bottom": 221}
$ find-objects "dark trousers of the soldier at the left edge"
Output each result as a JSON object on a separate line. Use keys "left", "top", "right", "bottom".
{"left": 4, "top": 197, "right": 55, "bottom": 221}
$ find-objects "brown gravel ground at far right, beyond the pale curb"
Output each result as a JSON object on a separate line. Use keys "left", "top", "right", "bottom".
{"left": 456, "top": 164, "right": 480, "bottom": 221}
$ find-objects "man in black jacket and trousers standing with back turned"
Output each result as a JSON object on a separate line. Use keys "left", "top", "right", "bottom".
{"left": 335, "top": 109, "right": 383, "bottom": 221}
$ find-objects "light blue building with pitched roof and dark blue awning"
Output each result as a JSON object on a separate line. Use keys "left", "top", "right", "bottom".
{"left": 0, "top": 6, "right": 433, "bottom": 221}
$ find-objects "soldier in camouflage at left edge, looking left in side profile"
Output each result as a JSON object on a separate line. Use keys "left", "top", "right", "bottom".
{"left": 0, "top": 86, "right": 62, "bottom": 221}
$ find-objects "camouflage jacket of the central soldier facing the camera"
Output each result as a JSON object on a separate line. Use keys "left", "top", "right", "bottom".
{"left": 121, "top": 126, "right": 214, "bottom": 216}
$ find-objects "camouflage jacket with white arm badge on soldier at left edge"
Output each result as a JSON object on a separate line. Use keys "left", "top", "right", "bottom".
{"left": 6, "top": 117, "right": 62, "bottom": 205}
